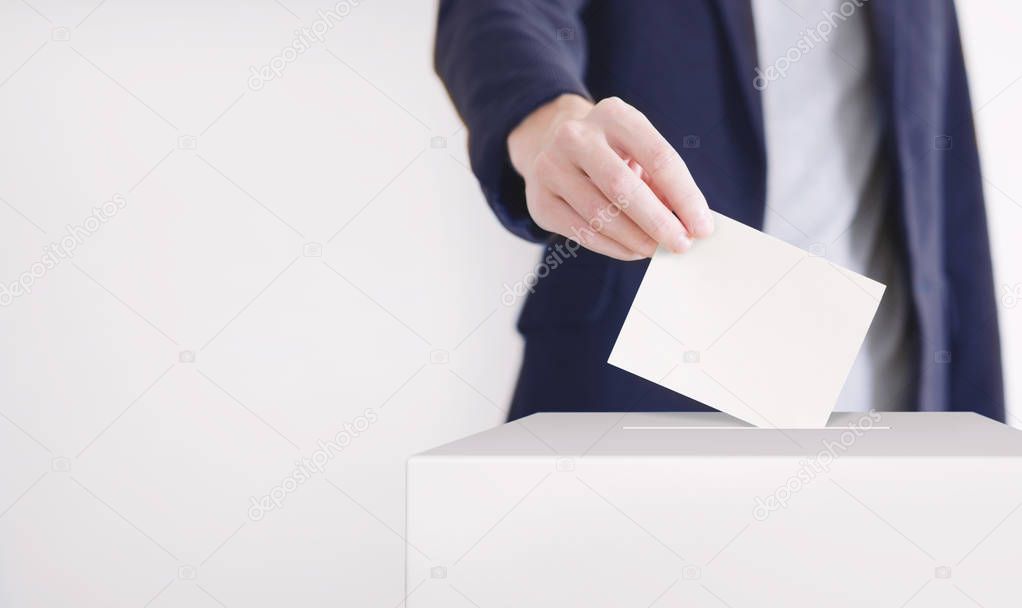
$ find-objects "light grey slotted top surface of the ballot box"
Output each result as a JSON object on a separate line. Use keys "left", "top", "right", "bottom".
{"left": 418, "top": 412, "right": 1022, "bottom": 458}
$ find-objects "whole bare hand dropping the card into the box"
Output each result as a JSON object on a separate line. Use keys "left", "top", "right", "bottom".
{"left": 508, "top": 95, "right": 713, "bottom": 260}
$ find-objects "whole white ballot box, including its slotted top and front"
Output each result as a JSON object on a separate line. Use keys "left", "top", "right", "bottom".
{"left": 406, "top": 413, "right": 1022, "bottom": 608}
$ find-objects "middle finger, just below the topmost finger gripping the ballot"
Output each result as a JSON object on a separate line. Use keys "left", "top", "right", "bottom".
{"left": 577, "top": 142, "right": 692, "bottom": 252}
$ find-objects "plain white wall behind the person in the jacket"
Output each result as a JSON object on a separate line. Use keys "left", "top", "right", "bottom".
{"left": 0, "top": 0, "right": 1022, "bottom": 607}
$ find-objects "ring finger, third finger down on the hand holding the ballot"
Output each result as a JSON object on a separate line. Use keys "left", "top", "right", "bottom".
{"left": 556, "top": 167, "right": 656, "bottom": 258}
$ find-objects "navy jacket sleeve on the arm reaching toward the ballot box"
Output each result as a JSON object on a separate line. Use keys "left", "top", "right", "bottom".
{"left": 434, "top": 0, "right": 590, "bottom": 241}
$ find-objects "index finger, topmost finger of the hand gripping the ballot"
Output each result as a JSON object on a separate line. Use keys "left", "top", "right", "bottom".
{"left": 597, "top": 98, "right": 713, "bottom": 237}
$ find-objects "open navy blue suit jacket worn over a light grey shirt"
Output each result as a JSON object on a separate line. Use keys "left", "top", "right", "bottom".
{"left": 435, "top": 0, "right": 1004, "bottom": 420}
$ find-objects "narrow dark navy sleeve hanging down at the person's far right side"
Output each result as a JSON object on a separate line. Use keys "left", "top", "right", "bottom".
{"left": 943, "top": 1, "right": 1005, "bottom": 420}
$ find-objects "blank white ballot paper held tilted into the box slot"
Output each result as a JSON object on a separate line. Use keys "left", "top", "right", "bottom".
{"left": 608, "top": 214, "right": 885, "bottom": 428}
